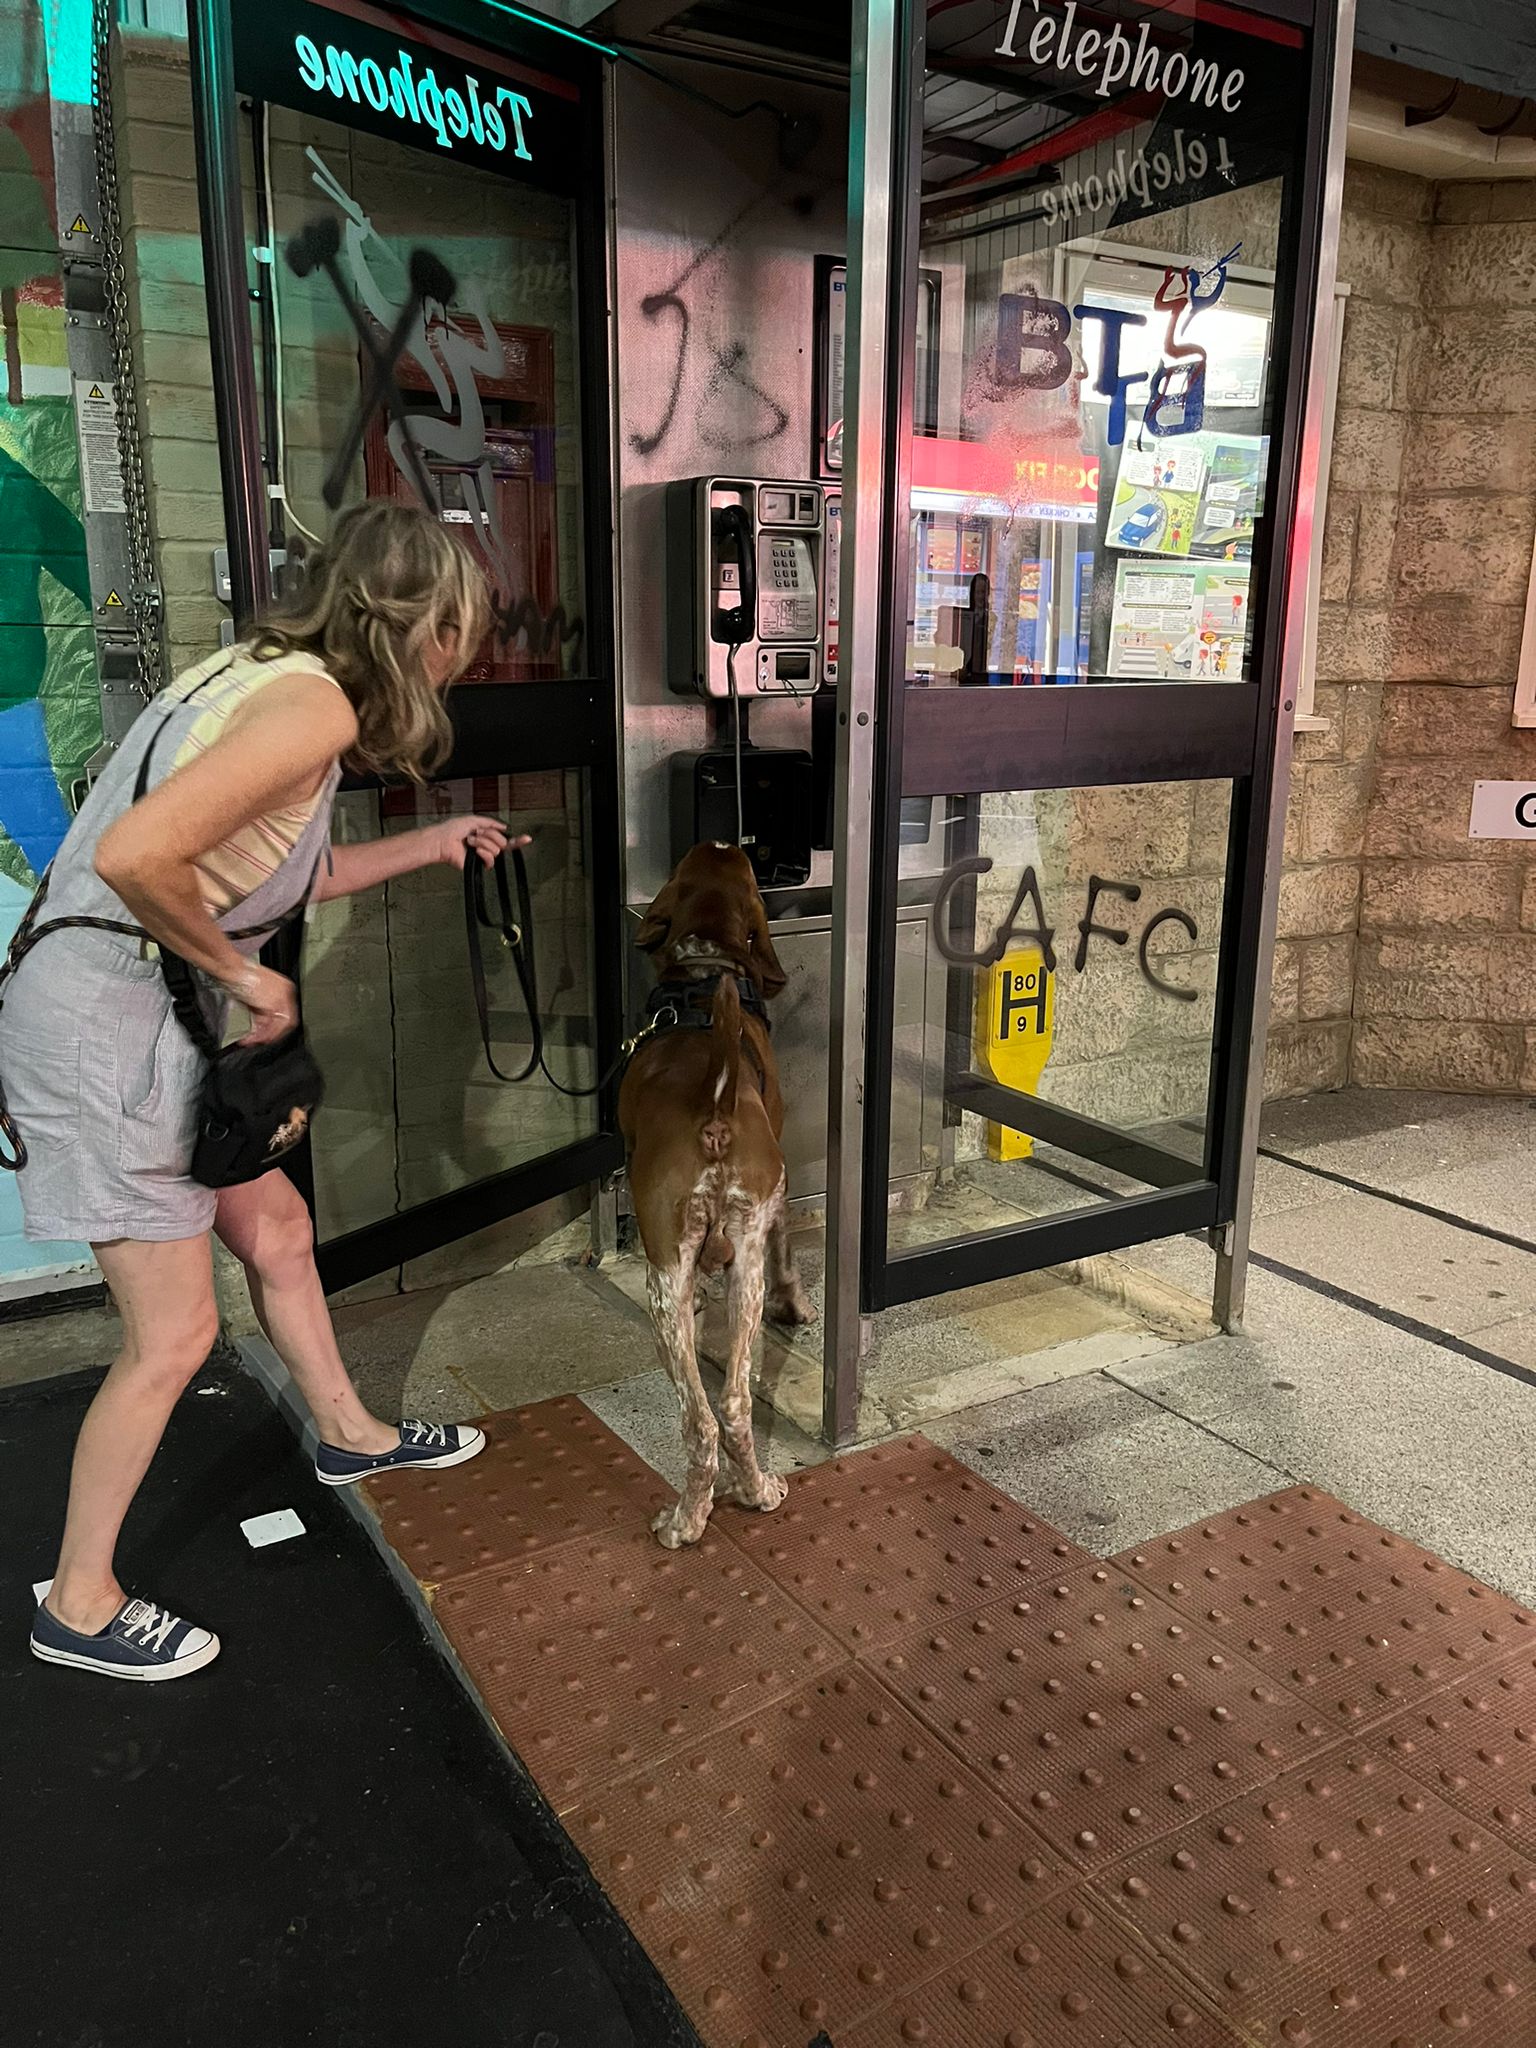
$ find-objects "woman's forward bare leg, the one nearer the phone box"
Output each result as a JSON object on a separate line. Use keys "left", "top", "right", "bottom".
{"left": 213, "top": 1174, "right": 399, "bottom": 1456}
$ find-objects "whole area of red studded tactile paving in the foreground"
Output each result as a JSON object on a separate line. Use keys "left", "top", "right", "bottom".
{"left": 371, "top": 1401, "right": 1536, "bottom": 2048}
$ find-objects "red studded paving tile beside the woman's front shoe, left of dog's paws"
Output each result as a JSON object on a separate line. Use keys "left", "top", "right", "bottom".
{"left": 365, "top": 1397, "right": 668, "bottom": 1587}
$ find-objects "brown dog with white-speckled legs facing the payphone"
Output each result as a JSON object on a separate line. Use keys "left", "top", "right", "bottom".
{"left": 618, "top": 846, "right": 813, "bottom": 1550}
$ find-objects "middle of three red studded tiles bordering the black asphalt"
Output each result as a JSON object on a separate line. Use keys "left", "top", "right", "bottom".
{"left": 434, "top": 1530, "right": 846, "bottom": 1812}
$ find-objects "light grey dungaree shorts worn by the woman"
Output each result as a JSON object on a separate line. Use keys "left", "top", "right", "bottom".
{"left": 0, "top": 655, "right": 340, "bottom": 1245}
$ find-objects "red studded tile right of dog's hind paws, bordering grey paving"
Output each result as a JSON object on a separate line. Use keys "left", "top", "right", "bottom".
{"left": 727, "top": 1436, "right": 1090, "bottom": 1653}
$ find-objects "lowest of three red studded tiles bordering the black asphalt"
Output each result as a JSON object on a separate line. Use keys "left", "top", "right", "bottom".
{"left": 565, "top": 1667, "right": 1069, "bottom": 2048}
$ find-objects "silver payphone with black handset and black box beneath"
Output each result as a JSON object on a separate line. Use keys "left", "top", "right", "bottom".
{"left": 668, "top": 477, "right": 842, "bottom": 889}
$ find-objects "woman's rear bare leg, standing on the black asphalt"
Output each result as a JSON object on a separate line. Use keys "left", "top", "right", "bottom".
{"left": 47, "top": 1233, "right": 219, "bottom": 1634}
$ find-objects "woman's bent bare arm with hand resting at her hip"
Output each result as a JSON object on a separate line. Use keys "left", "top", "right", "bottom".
{"left": 96, "top": 674, "right": 356, "bottom": 999}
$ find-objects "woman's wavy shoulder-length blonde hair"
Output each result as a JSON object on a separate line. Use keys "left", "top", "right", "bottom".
{"left": 250, "top": 498, "right": 492, "bottom": 782}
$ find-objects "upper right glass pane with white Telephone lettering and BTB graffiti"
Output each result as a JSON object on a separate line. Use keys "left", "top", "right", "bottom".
{"left": 909, "top": 0, "right": 1307, "bottom": 684}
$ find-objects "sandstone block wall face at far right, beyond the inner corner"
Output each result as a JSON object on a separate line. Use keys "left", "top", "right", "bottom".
{"left": 1350, "top": 180, "right": 1536, "bottom": 1092}
